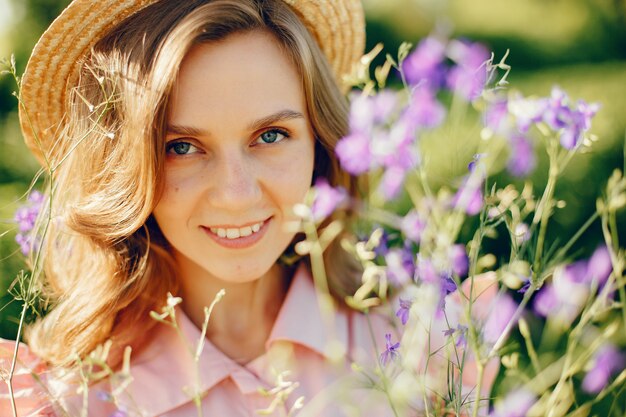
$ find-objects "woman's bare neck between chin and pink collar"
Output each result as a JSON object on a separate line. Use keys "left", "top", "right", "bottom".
{"left": 173, "top": 252, "right": 289, "bottom": 364}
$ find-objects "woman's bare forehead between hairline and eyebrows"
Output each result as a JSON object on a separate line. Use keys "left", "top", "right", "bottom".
{"left": 169, "top": 30, "right": 305, "bottom": 125}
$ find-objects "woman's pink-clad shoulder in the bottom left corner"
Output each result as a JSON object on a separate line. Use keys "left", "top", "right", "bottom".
{"left": 0, "top": 339, "right": 56, "bottom": 417}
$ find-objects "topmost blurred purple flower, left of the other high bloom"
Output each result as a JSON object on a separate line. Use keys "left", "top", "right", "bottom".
{"left": 402, "top": 36, "right": 446, "bottom": 88}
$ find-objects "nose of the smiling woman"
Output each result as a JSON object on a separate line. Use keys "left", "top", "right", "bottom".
{"left": 208, "top": 151, "right": 262, "bottom": 212}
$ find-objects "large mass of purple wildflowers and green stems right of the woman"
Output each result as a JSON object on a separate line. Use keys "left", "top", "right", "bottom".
{"left": 308, "top": 30, "right": 626, "bottom": 417}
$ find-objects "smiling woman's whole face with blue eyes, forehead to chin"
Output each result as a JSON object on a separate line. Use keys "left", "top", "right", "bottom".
{"left": 154, "top": 31, "right": 314, "bottom": 282}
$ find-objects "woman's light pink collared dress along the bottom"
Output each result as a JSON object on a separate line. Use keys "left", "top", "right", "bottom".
{"left": 0, "top": 267, "right": 397, "bottom": 417}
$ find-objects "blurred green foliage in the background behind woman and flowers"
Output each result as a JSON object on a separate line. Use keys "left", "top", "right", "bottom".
{"left": 0, "top": 0, "right": 626, "bottom": 348}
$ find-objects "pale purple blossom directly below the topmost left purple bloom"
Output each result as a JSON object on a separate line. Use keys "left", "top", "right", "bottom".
{"left": 401, "top": 86, "right": 446, "bottom": 129}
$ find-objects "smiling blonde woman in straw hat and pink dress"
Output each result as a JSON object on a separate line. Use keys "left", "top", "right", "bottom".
{"left": 2, "top": 0, "right": 394, "bottom": 416}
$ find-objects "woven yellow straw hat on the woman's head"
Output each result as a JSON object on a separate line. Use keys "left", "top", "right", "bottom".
{"left": 19, "top": 0, "right": 365, "bottom": 163}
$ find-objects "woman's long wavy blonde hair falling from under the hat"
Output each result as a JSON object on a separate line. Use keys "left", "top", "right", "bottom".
{"left": 26, "top": 0, "right": 358, "bottom": 365}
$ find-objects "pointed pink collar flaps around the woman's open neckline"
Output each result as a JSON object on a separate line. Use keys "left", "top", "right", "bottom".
{"left": 122, "top": 263, "right": 349, "bottom": 415}
